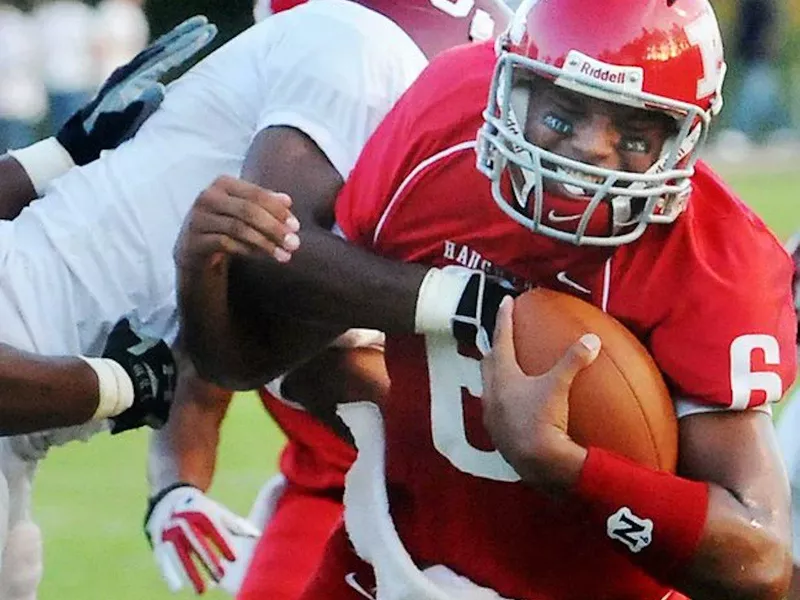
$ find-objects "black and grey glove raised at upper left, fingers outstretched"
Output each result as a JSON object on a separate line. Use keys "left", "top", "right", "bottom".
{"left": 56, "top": 16, "right": 217, "bottom": 165}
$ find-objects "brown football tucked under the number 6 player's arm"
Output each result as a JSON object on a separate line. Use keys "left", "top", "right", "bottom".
{"left": 514, "top": 288, "right": 678, "bottom": 472}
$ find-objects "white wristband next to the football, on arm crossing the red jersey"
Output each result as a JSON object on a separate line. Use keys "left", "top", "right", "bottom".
{"left": 414, "top": 266, "right": 478, "bottom": 333}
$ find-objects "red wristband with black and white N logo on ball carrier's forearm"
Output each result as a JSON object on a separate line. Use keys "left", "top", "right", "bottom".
{"left": 574, "top": 448, "right": 708, "bottom": 584}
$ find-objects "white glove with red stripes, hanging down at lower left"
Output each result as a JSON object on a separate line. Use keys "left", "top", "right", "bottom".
{"left": 144, "top": 484, "right": 261, "bottom": 594}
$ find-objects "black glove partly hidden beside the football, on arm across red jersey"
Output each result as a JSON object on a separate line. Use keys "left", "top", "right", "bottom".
{"left": 453, "top": 271, "right": 519, "bottom": 355}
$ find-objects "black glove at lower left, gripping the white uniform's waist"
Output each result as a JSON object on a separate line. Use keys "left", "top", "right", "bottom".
{"left": 103, "top": 319, "right": 176, "bottom": 434}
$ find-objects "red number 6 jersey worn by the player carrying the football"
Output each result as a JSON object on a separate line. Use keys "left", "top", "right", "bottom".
{"left": 306, "top": 44, "right": 796, "bottom": 600}
